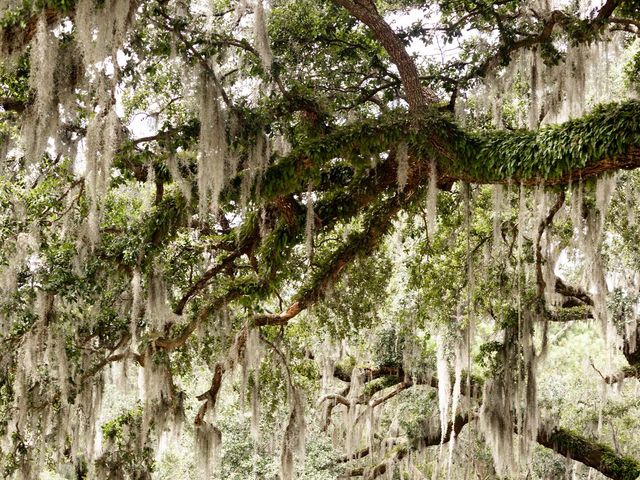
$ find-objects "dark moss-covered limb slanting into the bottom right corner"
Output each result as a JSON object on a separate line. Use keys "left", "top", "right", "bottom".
{"left": 537, "top": 428, "right": 640, "bottom": 480}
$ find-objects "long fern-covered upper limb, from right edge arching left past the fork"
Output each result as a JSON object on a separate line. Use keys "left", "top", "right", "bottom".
{"left": 241, "top": 101, "right": 640, "bottom": 208}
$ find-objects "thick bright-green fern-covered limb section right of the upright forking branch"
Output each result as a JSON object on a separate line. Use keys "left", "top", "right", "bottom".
{"left": 438, "top": 101, "right": 640, "bottom": 185}
